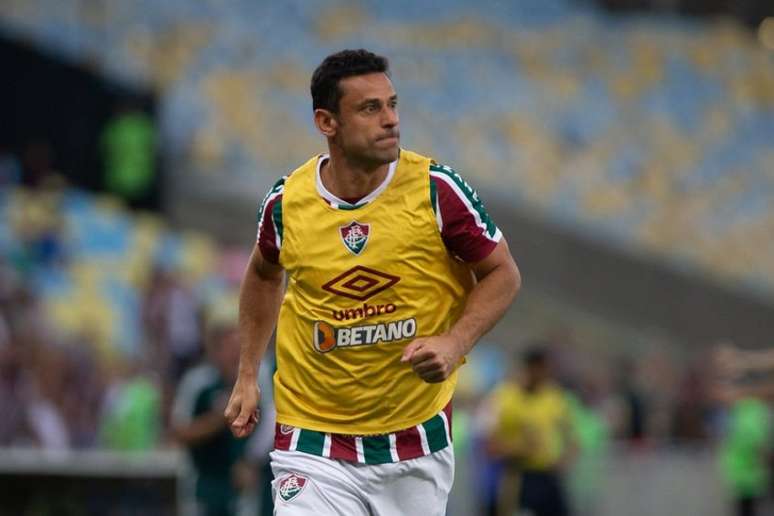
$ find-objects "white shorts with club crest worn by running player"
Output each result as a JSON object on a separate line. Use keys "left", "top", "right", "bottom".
{"left": 270, "top": 446, "right": 454, "bottom": 516}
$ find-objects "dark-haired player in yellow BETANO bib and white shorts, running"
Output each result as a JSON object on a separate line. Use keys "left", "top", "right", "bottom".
{"left": 225, "top": 50, "right": 520, "bottom": 516}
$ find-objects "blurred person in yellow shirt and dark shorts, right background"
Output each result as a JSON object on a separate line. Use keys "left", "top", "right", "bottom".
{"left": 492, "top": 344, "right": 574, "bottom": 516}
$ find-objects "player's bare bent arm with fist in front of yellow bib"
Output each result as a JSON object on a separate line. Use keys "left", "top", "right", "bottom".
{"left": 401, "top": 237, "right": 521, "bottom": 383}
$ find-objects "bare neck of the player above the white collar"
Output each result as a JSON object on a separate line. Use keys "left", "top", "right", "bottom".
{"left": 320, "top": 149, "right": 390, "bottom": 199}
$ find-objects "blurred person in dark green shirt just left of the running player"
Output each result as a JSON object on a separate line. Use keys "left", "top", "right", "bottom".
{"left": 172, "top": 314, "right": 257, "bottom": 516}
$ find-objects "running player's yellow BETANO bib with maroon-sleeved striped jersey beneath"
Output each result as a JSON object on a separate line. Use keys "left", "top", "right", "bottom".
{"left": 258, "top": 150, "right": 501, "bottom": 463}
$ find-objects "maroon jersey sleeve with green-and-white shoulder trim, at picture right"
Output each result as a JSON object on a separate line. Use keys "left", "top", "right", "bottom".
{"left": 430, "top": 164, "right": 502, "bottom": 262}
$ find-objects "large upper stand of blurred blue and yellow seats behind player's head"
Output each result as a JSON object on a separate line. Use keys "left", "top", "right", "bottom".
{"left": 0, "top": 0, "right": 774, "bottom": 297}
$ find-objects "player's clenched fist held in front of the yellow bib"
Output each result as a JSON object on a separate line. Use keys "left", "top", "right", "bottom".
{"left": 400, "top": 335, "right": 464, "bottom": 383}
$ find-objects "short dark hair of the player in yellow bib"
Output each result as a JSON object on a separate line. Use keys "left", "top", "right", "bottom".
{"left": 311, "top": 48, "right": 390, "bottom": 113}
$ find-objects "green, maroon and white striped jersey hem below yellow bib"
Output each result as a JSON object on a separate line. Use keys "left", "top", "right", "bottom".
{"left": 274, "top": 402, "right": 452, "bottom": 464}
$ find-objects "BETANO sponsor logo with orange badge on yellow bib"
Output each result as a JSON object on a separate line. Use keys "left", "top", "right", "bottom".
{"left": 314, "top": 317, "right": 417, "bottom": 353}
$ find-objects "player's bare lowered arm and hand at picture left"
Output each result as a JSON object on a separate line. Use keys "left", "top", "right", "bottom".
{"left": 225, "top": 244, "right": 284, "bottom": 437}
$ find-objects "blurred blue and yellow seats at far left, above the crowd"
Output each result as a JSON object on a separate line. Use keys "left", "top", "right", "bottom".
{"left": 0, "top": 184, "right": 233, "bottom": 357}
